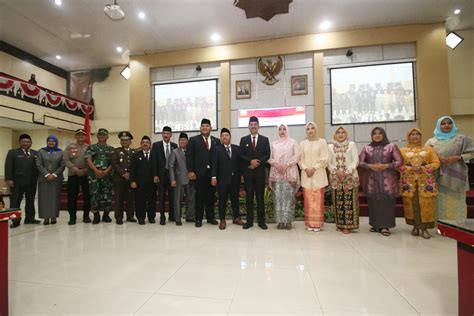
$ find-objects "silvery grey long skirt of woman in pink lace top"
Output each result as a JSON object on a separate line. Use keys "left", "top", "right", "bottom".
{"left": 273, "top": 181, "right": 295, "bottom": 224}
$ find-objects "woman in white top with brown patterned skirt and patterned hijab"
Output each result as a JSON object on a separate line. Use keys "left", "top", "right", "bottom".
{"left": 328, "top": 126, "right": 359, "bottom": 234}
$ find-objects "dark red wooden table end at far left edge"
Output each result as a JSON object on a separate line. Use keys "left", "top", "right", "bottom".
{"left": 0, "top": 209, "right": 21, "bottom": 316}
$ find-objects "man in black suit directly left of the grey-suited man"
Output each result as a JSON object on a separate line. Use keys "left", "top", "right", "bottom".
{"left": 151, "top": 126, "right": 178, "bottom": 225}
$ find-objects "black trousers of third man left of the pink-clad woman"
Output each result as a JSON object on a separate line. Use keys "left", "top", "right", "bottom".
{"left": 194, "top": 172, "right": 216, "bottom": 222}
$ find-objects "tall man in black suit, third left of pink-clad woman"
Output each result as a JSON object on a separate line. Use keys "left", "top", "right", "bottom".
{"left": 186, "top": 118, "right": 219, "bottom": 227}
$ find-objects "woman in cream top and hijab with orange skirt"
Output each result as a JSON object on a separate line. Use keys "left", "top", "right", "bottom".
{"left": 298, "top": 122, "right": 328, "bottom": 232}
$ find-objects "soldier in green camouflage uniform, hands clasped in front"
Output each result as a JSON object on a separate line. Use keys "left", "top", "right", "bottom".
{"left": 84, "top": 128, "right": 114, "bottom": 224}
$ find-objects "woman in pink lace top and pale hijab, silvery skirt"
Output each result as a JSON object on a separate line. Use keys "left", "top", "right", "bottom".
{"left": 268, "top": 124, "right": 300, "bottom": 229}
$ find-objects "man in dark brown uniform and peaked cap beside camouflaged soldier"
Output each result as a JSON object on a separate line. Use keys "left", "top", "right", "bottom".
{"left": 112, "top": 131, "right": 136, "bottom": 225}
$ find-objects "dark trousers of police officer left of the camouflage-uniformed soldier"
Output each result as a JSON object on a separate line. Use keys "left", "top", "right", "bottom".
{"left": 67, "top": 176, "right": 91, "bottom": 218}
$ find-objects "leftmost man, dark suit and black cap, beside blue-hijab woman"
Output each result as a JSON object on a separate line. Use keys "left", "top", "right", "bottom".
{"left": 5, "top": 134, "right": 40, "bottom": 228}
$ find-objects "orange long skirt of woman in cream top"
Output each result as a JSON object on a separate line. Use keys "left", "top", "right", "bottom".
{"left": 303, "top": 188, "right": 324, "bottom": 228}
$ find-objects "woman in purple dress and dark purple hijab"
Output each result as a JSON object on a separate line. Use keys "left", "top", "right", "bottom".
{"left": 359, "top": 127, "right": 402, "bottom": 236}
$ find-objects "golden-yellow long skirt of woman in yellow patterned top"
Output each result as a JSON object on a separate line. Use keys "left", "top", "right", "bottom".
{"left": 403, "top": 191, "right": 436, "bottom": 229}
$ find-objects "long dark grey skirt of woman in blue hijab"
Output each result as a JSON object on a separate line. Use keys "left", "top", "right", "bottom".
{"left": 38, "top": 181, "right": 61, "bottom": 219}
